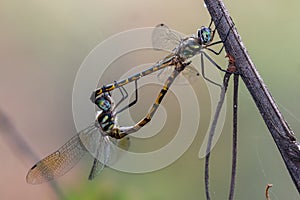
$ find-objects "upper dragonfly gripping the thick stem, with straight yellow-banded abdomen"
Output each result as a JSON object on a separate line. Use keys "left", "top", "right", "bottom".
{"left": 91, "top": 20, "right": 230, "bottom": 102}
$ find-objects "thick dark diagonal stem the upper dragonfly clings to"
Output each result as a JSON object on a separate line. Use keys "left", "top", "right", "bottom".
{"left": 204, "top": 0, "right": 300, "bottom": 192}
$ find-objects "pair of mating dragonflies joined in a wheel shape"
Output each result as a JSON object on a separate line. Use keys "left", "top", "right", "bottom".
{"left": 26, "top": 19, "right": 230, "bottom": 184}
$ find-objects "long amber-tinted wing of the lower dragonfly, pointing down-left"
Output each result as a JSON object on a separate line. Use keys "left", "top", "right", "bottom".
{"left": 26, "top": 127, "right": 94, "bottom": 184}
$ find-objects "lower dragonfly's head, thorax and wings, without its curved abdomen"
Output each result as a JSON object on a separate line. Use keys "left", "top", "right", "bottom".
{"left": 26, "top": 83, "right": 137, "bottom": 184}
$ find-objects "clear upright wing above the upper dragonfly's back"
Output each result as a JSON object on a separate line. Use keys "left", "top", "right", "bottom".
{"left": 152, "top": 24, "right": 184, "bottom": 51}
